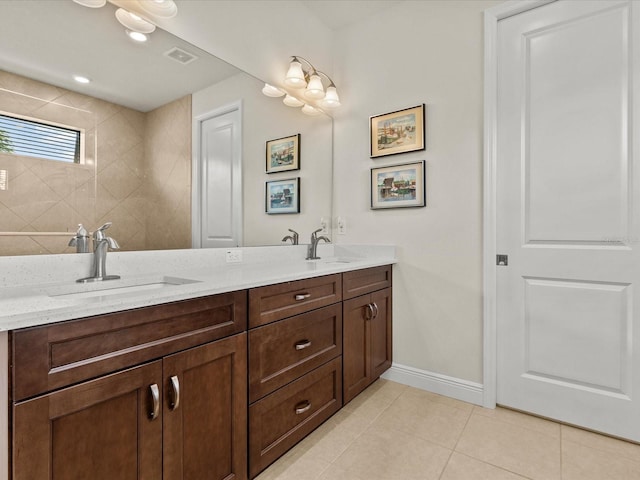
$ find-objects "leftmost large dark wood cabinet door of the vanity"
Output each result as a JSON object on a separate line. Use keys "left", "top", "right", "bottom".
{"left": 13, "top": 361, "right": 162, "bottom": 480}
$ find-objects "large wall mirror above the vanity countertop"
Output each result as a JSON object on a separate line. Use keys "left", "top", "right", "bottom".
{"left": 0, "top": 0, "right": 333, "bottom": 255}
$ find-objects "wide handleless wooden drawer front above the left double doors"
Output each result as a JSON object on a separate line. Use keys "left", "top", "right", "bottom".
{"left": 11, "top": 290, "right": 247, "bottom": 401}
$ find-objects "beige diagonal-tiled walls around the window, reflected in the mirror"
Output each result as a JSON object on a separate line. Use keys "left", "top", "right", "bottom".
{"left": 0, "top": 71, "right": 191, "bottom": 255}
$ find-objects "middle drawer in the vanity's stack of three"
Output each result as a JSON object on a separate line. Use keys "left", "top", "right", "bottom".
{"left": 249, "top": 303, "right": 342, "bottom": 402}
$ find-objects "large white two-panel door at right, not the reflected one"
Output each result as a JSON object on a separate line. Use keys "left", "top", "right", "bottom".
{"left": 496, "top": 0, "right": 640, "bottom": 441}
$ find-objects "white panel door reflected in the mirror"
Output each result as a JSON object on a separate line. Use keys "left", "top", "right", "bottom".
{"left": 193, "top": 105, "right": 242, "bottom": 248}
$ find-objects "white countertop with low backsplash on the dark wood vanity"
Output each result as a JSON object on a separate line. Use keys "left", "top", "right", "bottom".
{"left": 0, "top": 245, "right": 396, "bottom": 331}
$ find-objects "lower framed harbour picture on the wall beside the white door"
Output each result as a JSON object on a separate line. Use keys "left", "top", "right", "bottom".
{"left": 371, "top": 160, "right": 426, "bottom": 209}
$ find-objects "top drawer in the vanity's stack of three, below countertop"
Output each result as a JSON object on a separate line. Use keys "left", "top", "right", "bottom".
{"left": 249, "top": 274, "right": 342, "bottom": 328}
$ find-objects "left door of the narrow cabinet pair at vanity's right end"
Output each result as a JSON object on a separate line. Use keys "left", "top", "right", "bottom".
{"left": 342, "top": 295, "right": 371, "bottom": 404}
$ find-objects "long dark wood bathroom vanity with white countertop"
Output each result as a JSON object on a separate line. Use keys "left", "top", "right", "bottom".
{"left": 0, "top": 246, "right": 395, "bottom": 480}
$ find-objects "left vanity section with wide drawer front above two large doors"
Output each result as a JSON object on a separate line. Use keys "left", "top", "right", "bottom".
{"left": 12, "top": 292, "right": 247, "bottom": 480}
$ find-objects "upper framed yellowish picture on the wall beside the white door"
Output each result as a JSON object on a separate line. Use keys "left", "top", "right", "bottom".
{"left": 369, "top": 103, "right": 425, "bottom": 158}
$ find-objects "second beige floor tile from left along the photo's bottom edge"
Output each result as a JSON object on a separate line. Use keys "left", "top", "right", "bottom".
{"left": 332, "top": 426, "right": 451, "bottom": 480}
